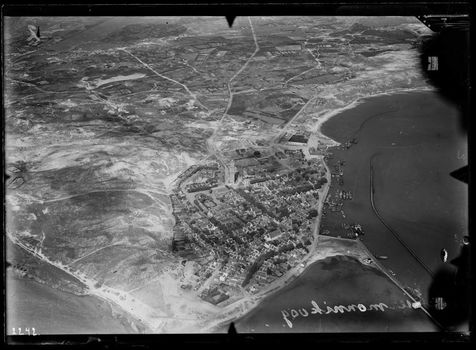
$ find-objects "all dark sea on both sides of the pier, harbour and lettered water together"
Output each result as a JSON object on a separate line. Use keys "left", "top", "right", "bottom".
{"left": 236, "top": 91, "right": 468, "bottom": 333}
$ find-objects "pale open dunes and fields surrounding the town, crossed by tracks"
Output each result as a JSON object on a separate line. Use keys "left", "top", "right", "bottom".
{"left": 4, "top": 17, "right": 446, "bottom": 332}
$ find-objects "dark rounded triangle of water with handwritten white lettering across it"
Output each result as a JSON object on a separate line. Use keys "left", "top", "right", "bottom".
{"left": 235, "top": 256, "right": 436, "bottom": 333}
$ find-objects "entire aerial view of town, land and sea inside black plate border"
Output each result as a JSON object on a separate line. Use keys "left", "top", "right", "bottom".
{"left": 3, "top": 16, "right": 470, "bottom": 335}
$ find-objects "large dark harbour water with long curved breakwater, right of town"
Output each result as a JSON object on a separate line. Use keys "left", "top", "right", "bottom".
{"left": 322, "top": 91, "right": 468, "bottom": 300}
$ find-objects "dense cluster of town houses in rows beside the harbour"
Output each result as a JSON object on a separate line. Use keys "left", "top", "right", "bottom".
{"left": 171, "top": 150, "right": 327, "bottom": 303}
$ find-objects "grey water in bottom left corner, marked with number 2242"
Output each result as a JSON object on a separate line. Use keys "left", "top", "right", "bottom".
{"left": 6, "top": 273, "right": 137, "bottom": 335}
